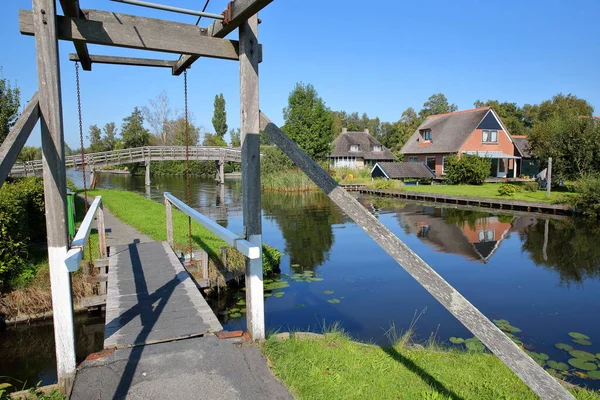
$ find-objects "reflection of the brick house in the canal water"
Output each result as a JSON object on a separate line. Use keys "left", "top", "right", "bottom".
{"left": 399, "top": 204, "right": 525, "bottom": 263}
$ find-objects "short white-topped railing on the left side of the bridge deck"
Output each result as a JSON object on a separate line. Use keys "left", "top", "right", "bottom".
{"left": 64, "top": 196, "right": 107, "bottom": 272}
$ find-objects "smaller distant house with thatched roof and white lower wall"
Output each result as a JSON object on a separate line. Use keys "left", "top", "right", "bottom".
{"left": 329, "top": 128, "right": 397, "bottom": 169}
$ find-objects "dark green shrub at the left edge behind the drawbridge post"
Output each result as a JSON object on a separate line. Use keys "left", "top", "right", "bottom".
{"left": 0, "top": 178, "right": 46, "bottom": 288}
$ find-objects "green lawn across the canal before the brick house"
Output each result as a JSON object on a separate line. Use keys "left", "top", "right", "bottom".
{"left": 400, "top": 183, "right": 574, "bottom": 203}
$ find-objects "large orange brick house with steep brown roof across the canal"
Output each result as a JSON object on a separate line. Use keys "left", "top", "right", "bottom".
{"left": 400, "top": 107, "right": 521, "bottom": 178}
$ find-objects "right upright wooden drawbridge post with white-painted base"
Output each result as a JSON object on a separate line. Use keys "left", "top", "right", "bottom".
{"left": 240, "top": 15, "right": 265, "bottom": 340}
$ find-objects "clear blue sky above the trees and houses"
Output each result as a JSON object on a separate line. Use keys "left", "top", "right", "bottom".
{"left": 0, "top": 0, "right": 600, "bottom": 147}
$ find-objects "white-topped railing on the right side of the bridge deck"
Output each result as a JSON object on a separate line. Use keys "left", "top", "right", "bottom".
{"left": 164, "top": 192, "right": 261, "bottom": 260}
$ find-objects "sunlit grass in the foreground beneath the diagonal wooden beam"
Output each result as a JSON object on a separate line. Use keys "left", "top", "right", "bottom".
{"left": 263, "top": 332, "right": 600, "bottom": 400}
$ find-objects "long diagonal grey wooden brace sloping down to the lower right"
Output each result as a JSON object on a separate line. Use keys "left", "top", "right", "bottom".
{"left": 260, "top": 115, "right": 574, "bottom": 400}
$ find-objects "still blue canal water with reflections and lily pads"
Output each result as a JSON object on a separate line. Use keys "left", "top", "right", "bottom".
{"left": 0, "top": 174, "right": 600, "bottom": 388}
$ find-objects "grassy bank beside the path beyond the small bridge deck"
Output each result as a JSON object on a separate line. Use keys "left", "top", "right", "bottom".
{"left": 88, "top": 189, "right": 280, "bottom": 273}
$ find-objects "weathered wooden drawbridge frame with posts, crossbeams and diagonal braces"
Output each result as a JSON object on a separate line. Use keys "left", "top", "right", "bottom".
{"left": 0, "top": 0, "right": 573, "bottom": 399}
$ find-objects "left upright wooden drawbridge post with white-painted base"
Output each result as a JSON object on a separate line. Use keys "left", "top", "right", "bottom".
{"left": 33, "top": 0, "right": 76, "bottom": 398}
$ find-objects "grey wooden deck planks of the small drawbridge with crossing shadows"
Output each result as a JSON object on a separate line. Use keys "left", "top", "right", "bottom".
{"left": 104, "top": 242, "right": 222, "bottom": 348}
